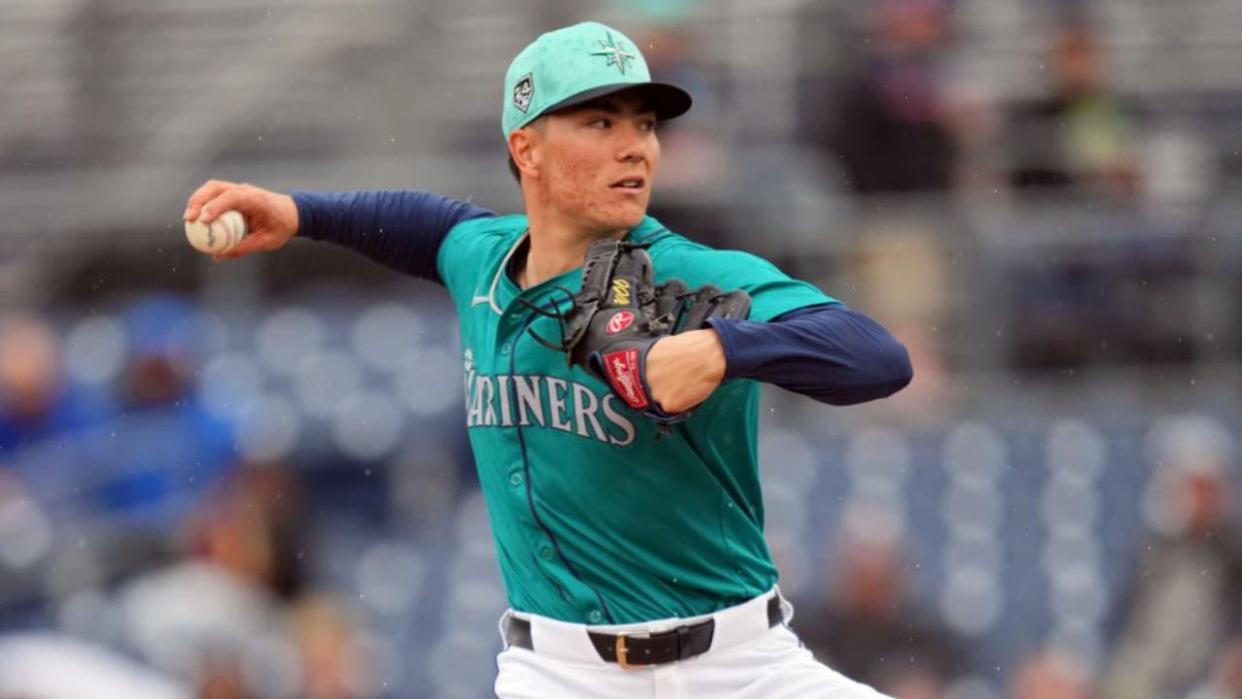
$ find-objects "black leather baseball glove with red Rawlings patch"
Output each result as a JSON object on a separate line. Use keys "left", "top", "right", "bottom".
{"left": 531, "top": 240, "right": 750, "bottom": 425}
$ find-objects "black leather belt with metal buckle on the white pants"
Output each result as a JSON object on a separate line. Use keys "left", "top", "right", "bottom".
{"left": 504, "top": 595, "right": 785, "bottom": 668}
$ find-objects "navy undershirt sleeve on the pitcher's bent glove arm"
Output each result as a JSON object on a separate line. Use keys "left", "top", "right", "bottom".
{"left": 709, "top": 303, "right": 914, "bottom": 405}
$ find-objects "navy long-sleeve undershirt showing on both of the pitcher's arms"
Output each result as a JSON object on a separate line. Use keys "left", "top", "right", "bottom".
{"left": 293, "top": 190, "right": 913, "bottom": 405}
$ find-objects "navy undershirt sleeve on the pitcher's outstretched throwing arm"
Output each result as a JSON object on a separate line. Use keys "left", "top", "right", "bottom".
{"left": 293, "top": 190, "right": 494, "bottom": 284}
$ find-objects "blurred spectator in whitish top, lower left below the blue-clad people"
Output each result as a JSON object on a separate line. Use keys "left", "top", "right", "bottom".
{"left": 122, "top": 466, "right": 376, "bottom": 699}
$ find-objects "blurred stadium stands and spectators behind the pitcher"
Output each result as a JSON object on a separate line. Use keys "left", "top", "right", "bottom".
{"left": 0, "top": 0, "right": 1242, "bottom": 699}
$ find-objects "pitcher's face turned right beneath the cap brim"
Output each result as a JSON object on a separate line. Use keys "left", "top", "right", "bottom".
{"left": 540, "top": 93, "right": 660, "bottom": 232}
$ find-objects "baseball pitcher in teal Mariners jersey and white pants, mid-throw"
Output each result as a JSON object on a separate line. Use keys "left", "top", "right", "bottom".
{"left": 185, "top": 22, "right": 912, "bottom": 698}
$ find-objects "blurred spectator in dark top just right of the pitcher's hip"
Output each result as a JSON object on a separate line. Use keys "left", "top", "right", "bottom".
{"left": 794, "top": 515, "right": 966, "bottom": 699}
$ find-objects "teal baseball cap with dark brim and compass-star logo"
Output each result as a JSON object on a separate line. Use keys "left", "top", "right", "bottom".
{"left": 501, "top": 22, "right": 691, "bottom": 138}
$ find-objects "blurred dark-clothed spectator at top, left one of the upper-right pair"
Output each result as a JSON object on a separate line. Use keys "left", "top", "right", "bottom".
{"left": 802, "top": 0, "right": 956, "bottom": 194}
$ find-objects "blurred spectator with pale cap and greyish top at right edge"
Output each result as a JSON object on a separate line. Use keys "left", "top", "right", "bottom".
{"left": 1104, "top": 417, "right": 1242, "bottom": 699}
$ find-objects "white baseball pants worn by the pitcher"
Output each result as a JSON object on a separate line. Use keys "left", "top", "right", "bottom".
{"left": 496, "top": 591, "right": 888, "bottom": 699}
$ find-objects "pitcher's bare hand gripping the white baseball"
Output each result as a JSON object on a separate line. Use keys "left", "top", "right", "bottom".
{"left": 183, "top": 180, "right": 298, "bottom": 261}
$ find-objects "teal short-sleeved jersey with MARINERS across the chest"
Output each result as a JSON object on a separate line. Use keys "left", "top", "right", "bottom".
{"left": 436, "top": 216, "right": 835, "bottom": 625}
